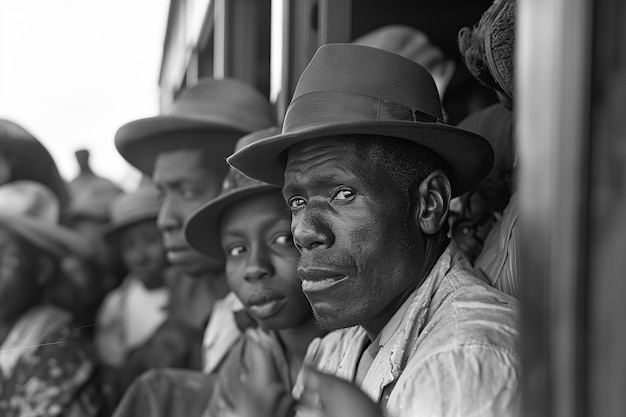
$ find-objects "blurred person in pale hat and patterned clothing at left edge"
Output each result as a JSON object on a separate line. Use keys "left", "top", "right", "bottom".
{"left": 0, "top": 181, "right": 100, "bottom": 417}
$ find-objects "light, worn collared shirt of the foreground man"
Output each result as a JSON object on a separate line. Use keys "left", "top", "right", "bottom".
{"left": 293, "top": 243, "right": 520, "bottom": 417}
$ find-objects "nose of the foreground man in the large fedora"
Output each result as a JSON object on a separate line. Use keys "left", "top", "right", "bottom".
{"left": 291, "top": 208, "right": 335, "bottom": 252}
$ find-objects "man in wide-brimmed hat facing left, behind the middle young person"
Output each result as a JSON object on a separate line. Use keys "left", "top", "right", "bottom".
{"left": 115, "top": 79, "right": 275, "bottom": 382}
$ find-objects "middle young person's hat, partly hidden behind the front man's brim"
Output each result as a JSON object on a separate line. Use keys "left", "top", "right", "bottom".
{"left": 185, "top": 127, "right": 280, "bottom": 258}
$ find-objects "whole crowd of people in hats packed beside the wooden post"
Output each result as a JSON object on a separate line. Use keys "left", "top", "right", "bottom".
{"left": 0, "top": 0, "right": 521, "bottom": 417}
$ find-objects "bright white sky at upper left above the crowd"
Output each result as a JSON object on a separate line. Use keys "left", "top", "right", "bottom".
{"left": 0, "top": 0, "right": 169, "bottom": 189}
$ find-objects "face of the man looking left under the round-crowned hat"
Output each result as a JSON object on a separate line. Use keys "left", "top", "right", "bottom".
{"left": 152, "top": 149, "right": 223, "bottom": 275}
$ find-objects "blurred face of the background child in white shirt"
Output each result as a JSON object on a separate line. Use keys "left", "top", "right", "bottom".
{"left": 119, "top": 219, "right": 167, "bottom": 288}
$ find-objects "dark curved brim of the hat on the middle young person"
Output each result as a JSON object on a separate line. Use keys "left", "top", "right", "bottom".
{"left": 185, "top": 184, "right": 280, "bottom": 259}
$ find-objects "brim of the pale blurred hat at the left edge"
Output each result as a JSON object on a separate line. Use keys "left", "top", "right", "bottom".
{"left": 0, "top": 214, "right": 94, "bottom": 259}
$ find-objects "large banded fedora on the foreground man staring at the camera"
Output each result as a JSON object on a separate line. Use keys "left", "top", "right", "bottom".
{"left": 228, "top": 44, "right": 493, "bottom": 195}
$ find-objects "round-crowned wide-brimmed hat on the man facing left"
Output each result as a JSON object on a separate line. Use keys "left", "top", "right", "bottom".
{"left": 115, "top": 78, "right": 276, "bottom": 176}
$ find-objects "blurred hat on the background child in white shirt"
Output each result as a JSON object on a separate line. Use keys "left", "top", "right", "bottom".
{"left": 104, "top": 182, "right": 161, "bottom": 241}
